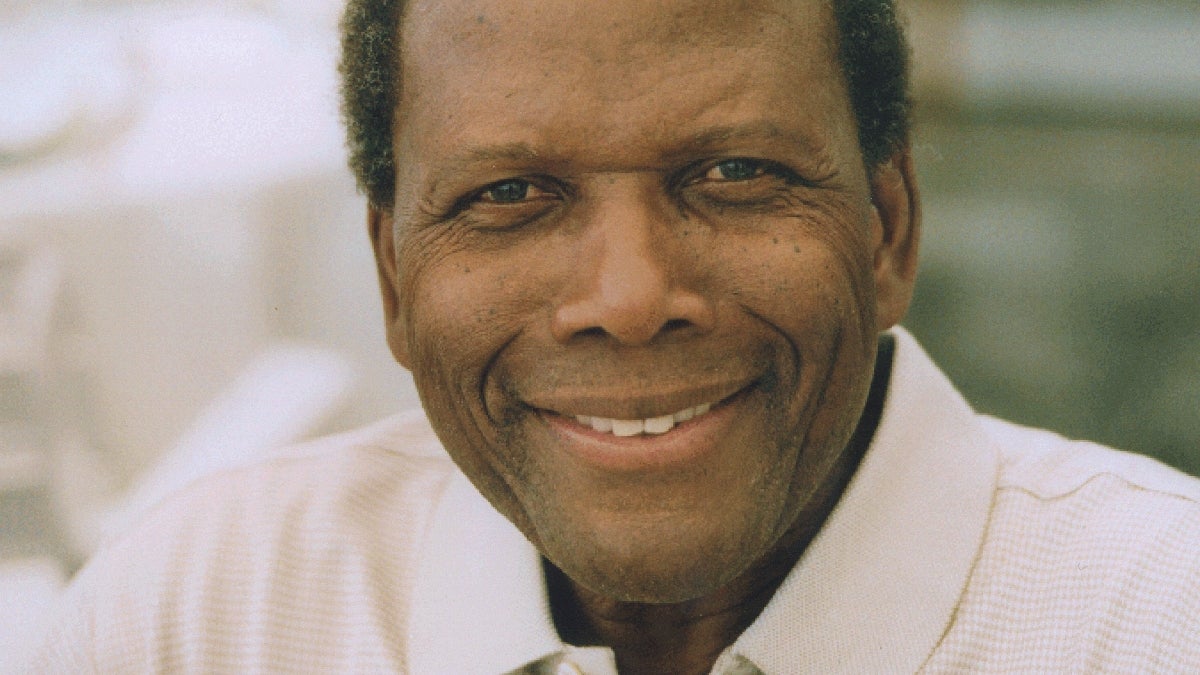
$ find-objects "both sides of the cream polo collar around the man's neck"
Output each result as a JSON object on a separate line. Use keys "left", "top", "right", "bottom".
{"left": 408, "top": 329, "right": 998, "bottom": 675}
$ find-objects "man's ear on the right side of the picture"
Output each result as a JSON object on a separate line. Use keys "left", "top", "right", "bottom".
{"left": 871, "top": 145, "right": 920, "bottom": 330}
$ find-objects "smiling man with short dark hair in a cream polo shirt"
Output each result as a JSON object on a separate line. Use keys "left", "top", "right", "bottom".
{"left": 37, "top": 0, "right": 1200, "bottom": 674}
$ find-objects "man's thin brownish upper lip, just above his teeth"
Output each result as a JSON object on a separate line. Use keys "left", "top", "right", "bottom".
{"left": 524, "top": 377, "right": 754, "bottom": 419}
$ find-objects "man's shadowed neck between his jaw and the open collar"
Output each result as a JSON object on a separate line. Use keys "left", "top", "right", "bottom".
{"left": 544, "top": 336, "right": 893, "bottom": 675}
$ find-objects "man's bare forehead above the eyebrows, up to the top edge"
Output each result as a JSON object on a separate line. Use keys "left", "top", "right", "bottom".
{"left": 397, "top": 0, "right": 848, "bottom": 174}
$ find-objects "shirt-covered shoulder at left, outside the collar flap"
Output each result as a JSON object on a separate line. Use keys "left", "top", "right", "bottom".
{"left": 36, "top": 414, "right": 455, "bottom": 671}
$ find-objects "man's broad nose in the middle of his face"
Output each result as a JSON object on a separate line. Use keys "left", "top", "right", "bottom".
{"left": 552, "top": 186, "right": 714, "bottom": 345}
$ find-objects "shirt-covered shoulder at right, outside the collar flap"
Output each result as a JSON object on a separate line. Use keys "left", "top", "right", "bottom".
{"left": 935, "top": 418, "right": 1200, "bottom": 671}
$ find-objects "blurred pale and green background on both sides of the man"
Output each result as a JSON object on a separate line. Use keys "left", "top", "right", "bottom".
{"left": 0, "top": 0, "right": 1200, "bottom": 671}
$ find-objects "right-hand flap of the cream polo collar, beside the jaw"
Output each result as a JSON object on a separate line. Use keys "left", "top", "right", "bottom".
{"left": 733, "top": 328, "right": 1000, "bottom": 673}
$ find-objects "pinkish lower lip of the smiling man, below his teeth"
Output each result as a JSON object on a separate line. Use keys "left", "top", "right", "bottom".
{"left": 541, "top": 392, "right": 745, "bottom": 472}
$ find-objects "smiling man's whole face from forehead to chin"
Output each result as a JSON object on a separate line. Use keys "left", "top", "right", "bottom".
{"left": 373, "top": 0, "right": 911, "bottom": 602}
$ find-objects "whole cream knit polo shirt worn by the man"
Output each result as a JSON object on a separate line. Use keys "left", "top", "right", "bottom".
{"left": 38, "top": 330, "right": 1200, "bottom": 675}
